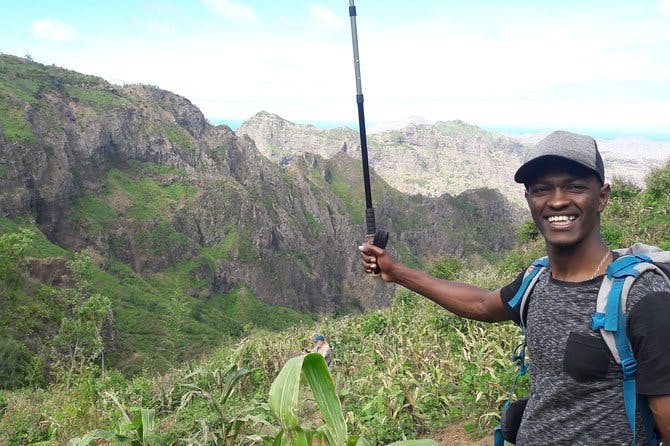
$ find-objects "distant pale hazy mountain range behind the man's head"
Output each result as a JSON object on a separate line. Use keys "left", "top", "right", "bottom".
{"left": 238, "top": 112, "right": 670, "bottom": 209}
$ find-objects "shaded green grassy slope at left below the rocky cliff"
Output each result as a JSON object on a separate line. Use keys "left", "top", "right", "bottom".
{"left": 0, "top": 209, "right": 313, "bottom": 388}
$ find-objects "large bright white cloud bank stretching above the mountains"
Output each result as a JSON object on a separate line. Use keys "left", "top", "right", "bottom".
{"left": 44, "top": 0, "right": 670, "bottom": 136}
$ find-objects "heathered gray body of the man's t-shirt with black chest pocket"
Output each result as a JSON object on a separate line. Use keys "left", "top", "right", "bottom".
{"left": 503, "top": 266, "right": 670, "bottom": 446}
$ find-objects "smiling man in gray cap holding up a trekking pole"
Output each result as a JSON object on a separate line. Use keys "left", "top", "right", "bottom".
{"left": 359, "top": 131, "right": 670, "bottom": 446}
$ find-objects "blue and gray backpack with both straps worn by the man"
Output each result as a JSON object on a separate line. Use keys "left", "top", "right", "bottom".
{"left": 494, "top": 243, "right": 670, "bottom": 446}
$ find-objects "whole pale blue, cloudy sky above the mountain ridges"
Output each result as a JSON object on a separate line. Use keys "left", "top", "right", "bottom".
{"left": 0, "top": 0, "right": 670, "bottom": 140}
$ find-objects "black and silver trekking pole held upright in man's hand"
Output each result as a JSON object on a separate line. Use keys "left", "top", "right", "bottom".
{"left": 349, "top": 0, "right": 388, "bottom": 262}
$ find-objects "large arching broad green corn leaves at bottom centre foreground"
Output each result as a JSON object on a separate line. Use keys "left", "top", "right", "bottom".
{"left": 264, "top": 353, "right": 437, "bottom": 446}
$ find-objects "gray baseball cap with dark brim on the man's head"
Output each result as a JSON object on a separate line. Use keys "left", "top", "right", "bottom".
{"left": 514, "top": 130, "right": 605, "bottom": 184}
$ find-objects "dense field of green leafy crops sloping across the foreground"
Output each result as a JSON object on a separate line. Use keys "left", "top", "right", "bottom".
{"left": 0, "top": 271, "right": 518, "bottom": 444}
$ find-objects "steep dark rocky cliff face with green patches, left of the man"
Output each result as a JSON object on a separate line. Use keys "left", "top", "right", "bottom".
{"left": 0, "top": 56, "right": 518, "bottom": 312}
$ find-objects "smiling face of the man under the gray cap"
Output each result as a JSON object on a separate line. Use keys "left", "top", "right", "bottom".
{"left": 525, "top": 163, "right": 609, "bottom": 247}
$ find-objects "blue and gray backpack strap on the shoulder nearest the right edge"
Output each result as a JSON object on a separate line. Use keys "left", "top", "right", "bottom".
{"left": 592, "top": 254, "right": 668, "bottom": 446}
